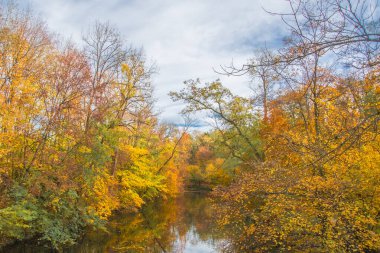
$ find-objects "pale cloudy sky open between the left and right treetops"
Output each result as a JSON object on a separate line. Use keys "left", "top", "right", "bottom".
{"left": 21, "top": 0, "right": 287, "bottom": 126}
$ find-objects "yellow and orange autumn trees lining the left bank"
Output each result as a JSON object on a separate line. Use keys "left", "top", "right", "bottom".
{"left": 0, "top": 2, "right": 189, "bottom": 249}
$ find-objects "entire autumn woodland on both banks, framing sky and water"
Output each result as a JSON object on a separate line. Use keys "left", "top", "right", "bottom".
{"left": 0, "top": 0, "right": 380, "bottom": 252}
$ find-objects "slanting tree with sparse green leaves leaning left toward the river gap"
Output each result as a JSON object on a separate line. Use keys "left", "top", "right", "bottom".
{"left": 170, "top": 80, "right": 263, "bottom": 166}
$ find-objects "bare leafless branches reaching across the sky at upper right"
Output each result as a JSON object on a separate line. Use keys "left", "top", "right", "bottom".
{"left": 222, "top": 0, "right": 380, "bottom": 75}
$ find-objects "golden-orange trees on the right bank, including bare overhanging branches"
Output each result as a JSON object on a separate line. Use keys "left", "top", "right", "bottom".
{"left": 173, "top": 0, "right": 380, "bottom": 252}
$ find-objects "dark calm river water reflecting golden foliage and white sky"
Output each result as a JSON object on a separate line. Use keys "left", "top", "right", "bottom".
{"left": 4, "top": 193, "right": 223, "bottom": 253}
